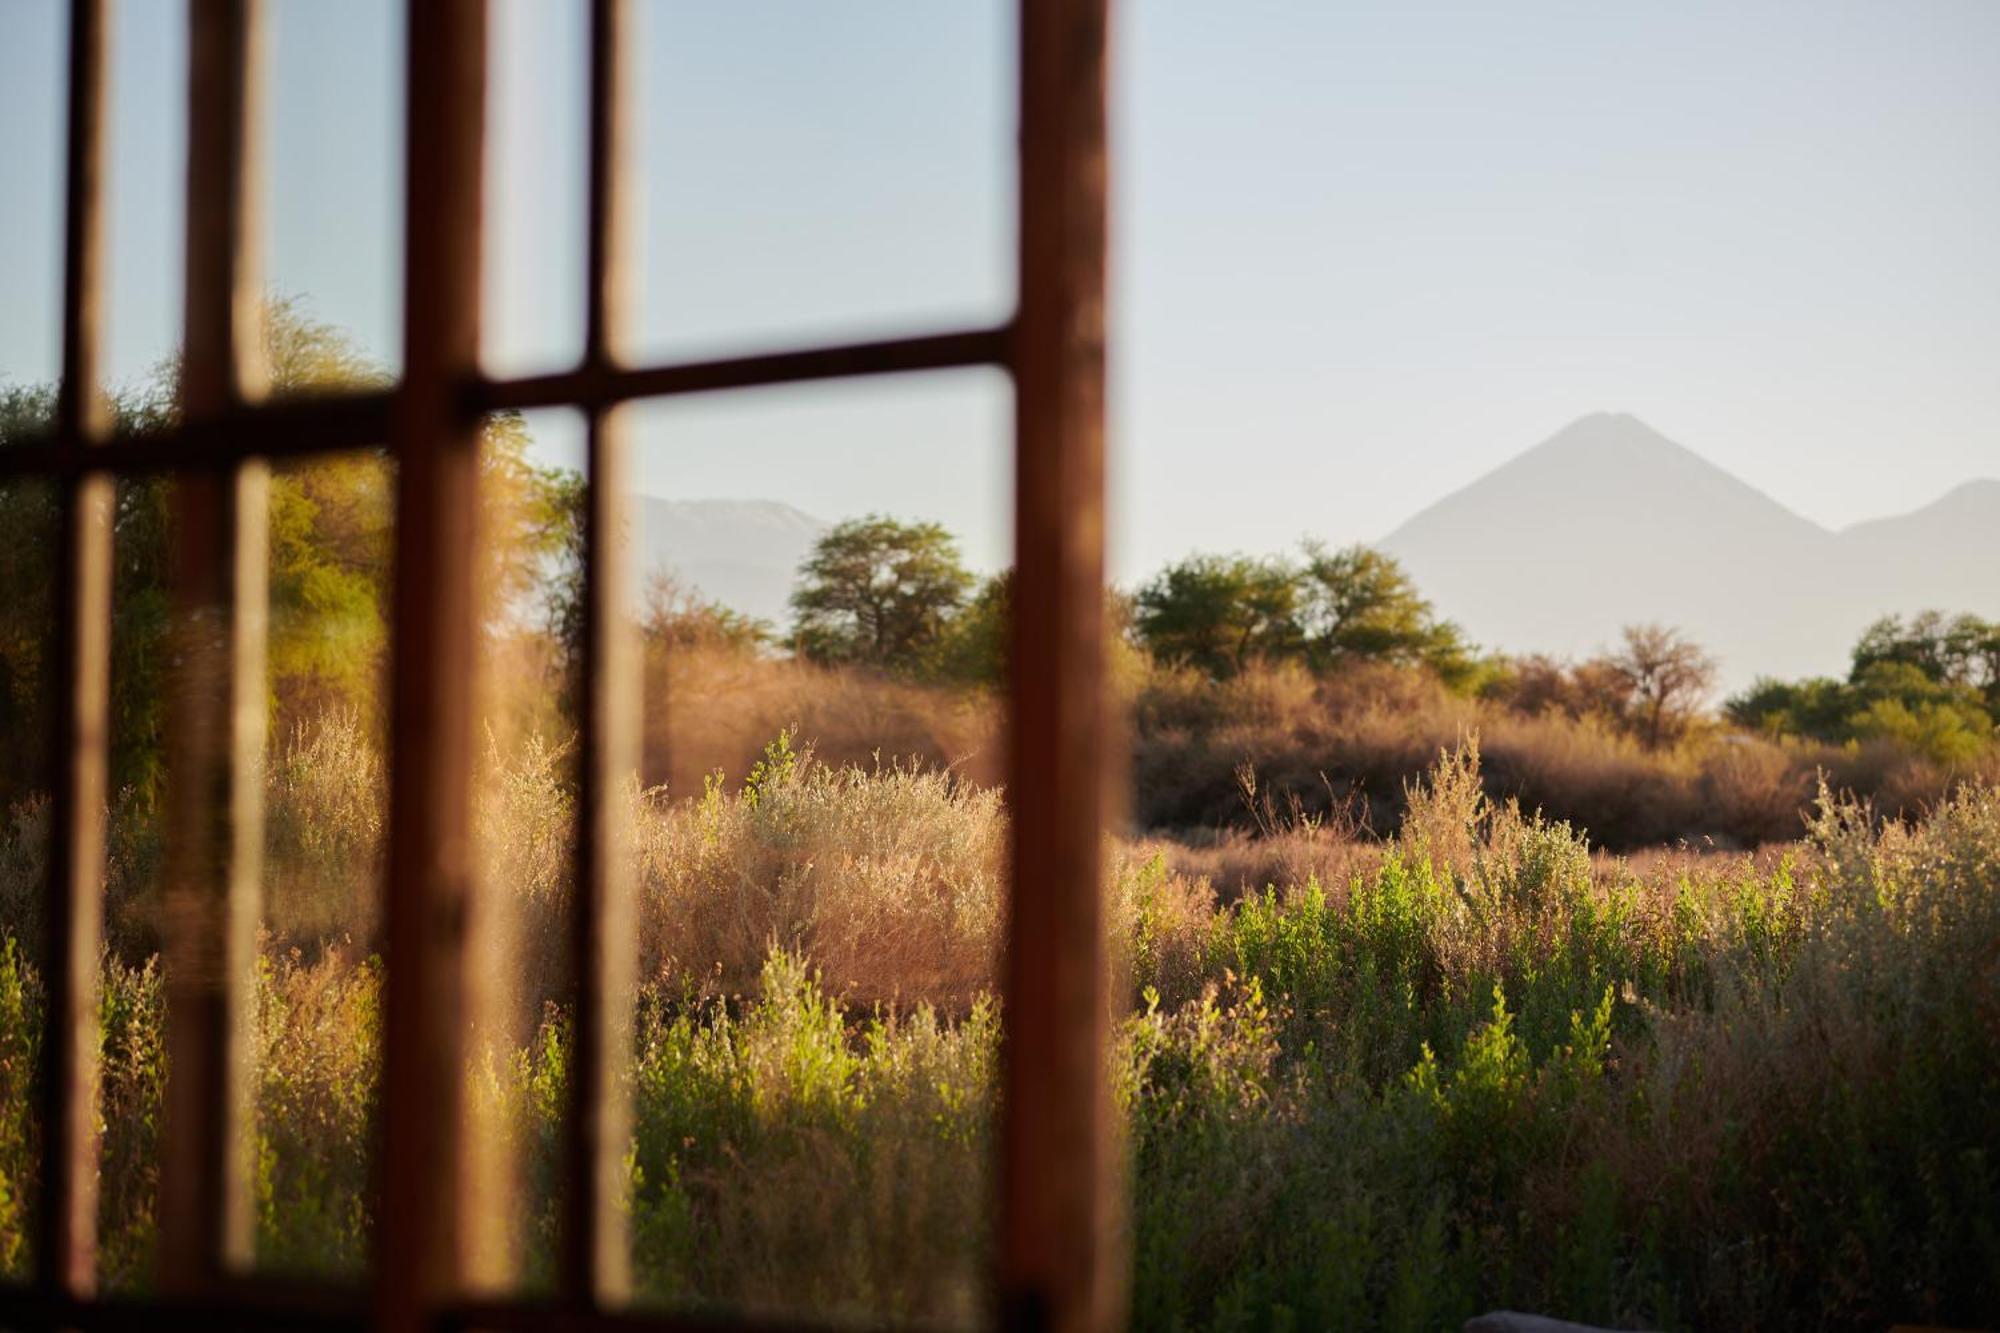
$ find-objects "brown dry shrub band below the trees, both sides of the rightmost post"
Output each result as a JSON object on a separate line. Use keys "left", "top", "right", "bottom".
{"left": 648, "top": 642, "right": 2000, "bottom": 852}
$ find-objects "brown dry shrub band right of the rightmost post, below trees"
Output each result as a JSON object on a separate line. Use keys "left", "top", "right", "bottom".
{"left": 1132, "top": 662, "right": 2000, "bottom": 851}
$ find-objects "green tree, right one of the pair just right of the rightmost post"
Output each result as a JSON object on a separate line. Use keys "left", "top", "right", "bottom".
{"left": 1300, "top": 542, "right": 1474, "bottom": 685}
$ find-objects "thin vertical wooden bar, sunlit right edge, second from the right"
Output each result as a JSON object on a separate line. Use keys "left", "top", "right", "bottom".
{"left": 560, "top": 0, "right": 640, "bottom": 1309}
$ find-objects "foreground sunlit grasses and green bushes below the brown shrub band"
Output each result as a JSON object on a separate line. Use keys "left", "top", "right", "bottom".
{"left": 0, "top": 712, "right": 2000, "bottom": 1329}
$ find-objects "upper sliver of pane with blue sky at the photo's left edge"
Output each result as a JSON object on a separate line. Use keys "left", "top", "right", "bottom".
{"left": 0, "top": 0, "right": 70, "bottom": 390}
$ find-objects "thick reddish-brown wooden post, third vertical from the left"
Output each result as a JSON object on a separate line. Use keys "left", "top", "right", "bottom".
{"left": 376, "top": 0, "right": 486, "bottom": 1333}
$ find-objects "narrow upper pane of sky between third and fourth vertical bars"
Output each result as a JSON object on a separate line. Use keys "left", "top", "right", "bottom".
{"left": 480, "top": 0, "right": 590, "bottom": 374}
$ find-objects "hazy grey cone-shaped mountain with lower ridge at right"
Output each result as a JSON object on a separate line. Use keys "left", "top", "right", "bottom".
{"left": 1378, "top": 412, "right": 2000, "bottom": 689}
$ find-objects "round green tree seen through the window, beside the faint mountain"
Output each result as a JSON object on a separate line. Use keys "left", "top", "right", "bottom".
{"left": 792, "top": 514, "right": 972, "bottom": 671}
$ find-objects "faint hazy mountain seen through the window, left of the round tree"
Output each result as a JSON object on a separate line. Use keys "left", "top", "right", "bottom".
{"left": 638, "top": 494, "right": 828, "bottom": 630}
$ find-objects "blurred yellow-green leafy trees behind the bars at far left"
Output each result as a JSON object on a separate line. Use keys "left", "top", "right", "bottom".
{"left": 0, "top": 300, "right": 582, "bottom": 803}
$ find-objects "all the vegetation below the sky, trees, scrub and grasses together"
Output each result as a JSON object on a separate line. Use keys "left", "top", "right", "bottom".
{"left": 0, "top": 314, "right": 2000, "bottom": 1331}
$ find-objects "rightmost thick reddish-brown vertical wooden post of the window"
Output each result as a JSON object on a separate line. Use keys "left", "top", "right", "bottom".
{"left": 1000, "top": 0, "right": 1124, "bottom": 1333}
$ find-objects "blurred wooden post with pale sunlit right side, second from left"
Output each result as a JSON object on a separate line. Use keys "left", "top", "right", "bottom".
{"left": 160, "top": 0, "right": 268, "bottom": 1293}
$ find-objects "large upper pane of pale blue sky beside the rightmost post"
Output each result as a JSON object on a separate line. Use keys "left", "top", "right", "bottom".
{"left": 636, "top": 0, "right": 1014, "bottom": 358}
